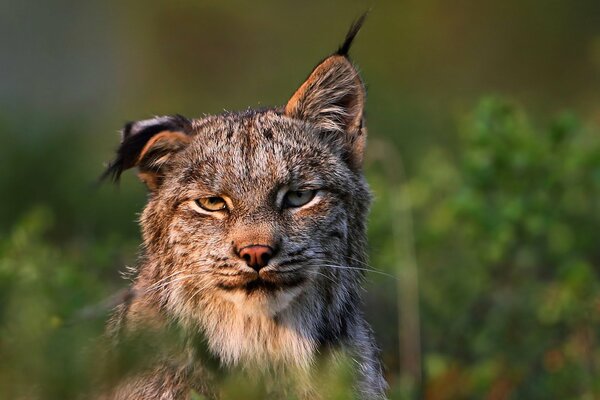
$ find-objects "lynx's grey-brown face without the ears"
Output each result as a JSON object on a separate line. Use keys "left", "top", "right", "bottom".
{"left": 148, "top": 111, "right": 368, "bottom": 315}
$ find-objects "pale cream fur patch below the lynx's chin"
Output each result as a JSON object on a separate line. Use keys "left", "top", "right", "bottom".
{"left": 193, "top": 289, "right": 317, "bottom": 371}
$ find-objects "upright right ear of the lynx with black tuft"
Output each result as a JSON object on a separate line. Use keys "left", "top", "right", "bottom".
{"left": 284, "top": 15, "right": 366, "bottom": 166}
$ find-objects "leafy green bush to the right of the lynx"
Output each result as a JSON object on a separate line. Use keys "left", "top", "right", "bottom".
{"left": 408, "top": 99, "right": 600, "bottom": 398}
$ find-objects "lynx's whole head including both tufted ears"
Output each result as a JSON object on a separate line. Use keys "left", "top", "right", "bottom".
{"left": 107, "top": 18, "right": 370, "bottom": 342}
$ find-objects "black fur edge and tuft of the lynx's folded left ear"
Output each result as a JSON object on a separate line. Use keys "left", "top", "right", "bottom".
{"left": 100, "top": 115, "right": 191, "bottom": 182}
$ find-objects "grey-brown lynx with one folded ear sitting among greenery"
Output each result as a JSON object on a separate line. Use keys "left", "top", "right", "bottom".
{"left": 105, "top": 17, "right": 386, "bottom": 399}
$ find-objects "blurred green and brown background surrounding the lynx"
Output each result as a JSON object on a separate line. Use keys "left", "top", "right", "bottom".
{"left": 0, "top": 0, "right": 600, "bottom": 399}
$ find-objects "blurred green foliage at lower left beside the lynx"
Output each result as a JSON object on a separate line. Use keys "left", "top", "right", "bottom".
{"left": 0, "top": 208, "right": 106, "bottom": 398}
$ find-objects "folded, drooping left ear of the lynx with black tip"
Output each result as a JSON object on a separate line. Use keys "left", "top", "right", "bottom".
{"left": 102, "top": 115, "right": 191, "bottom": 191}
